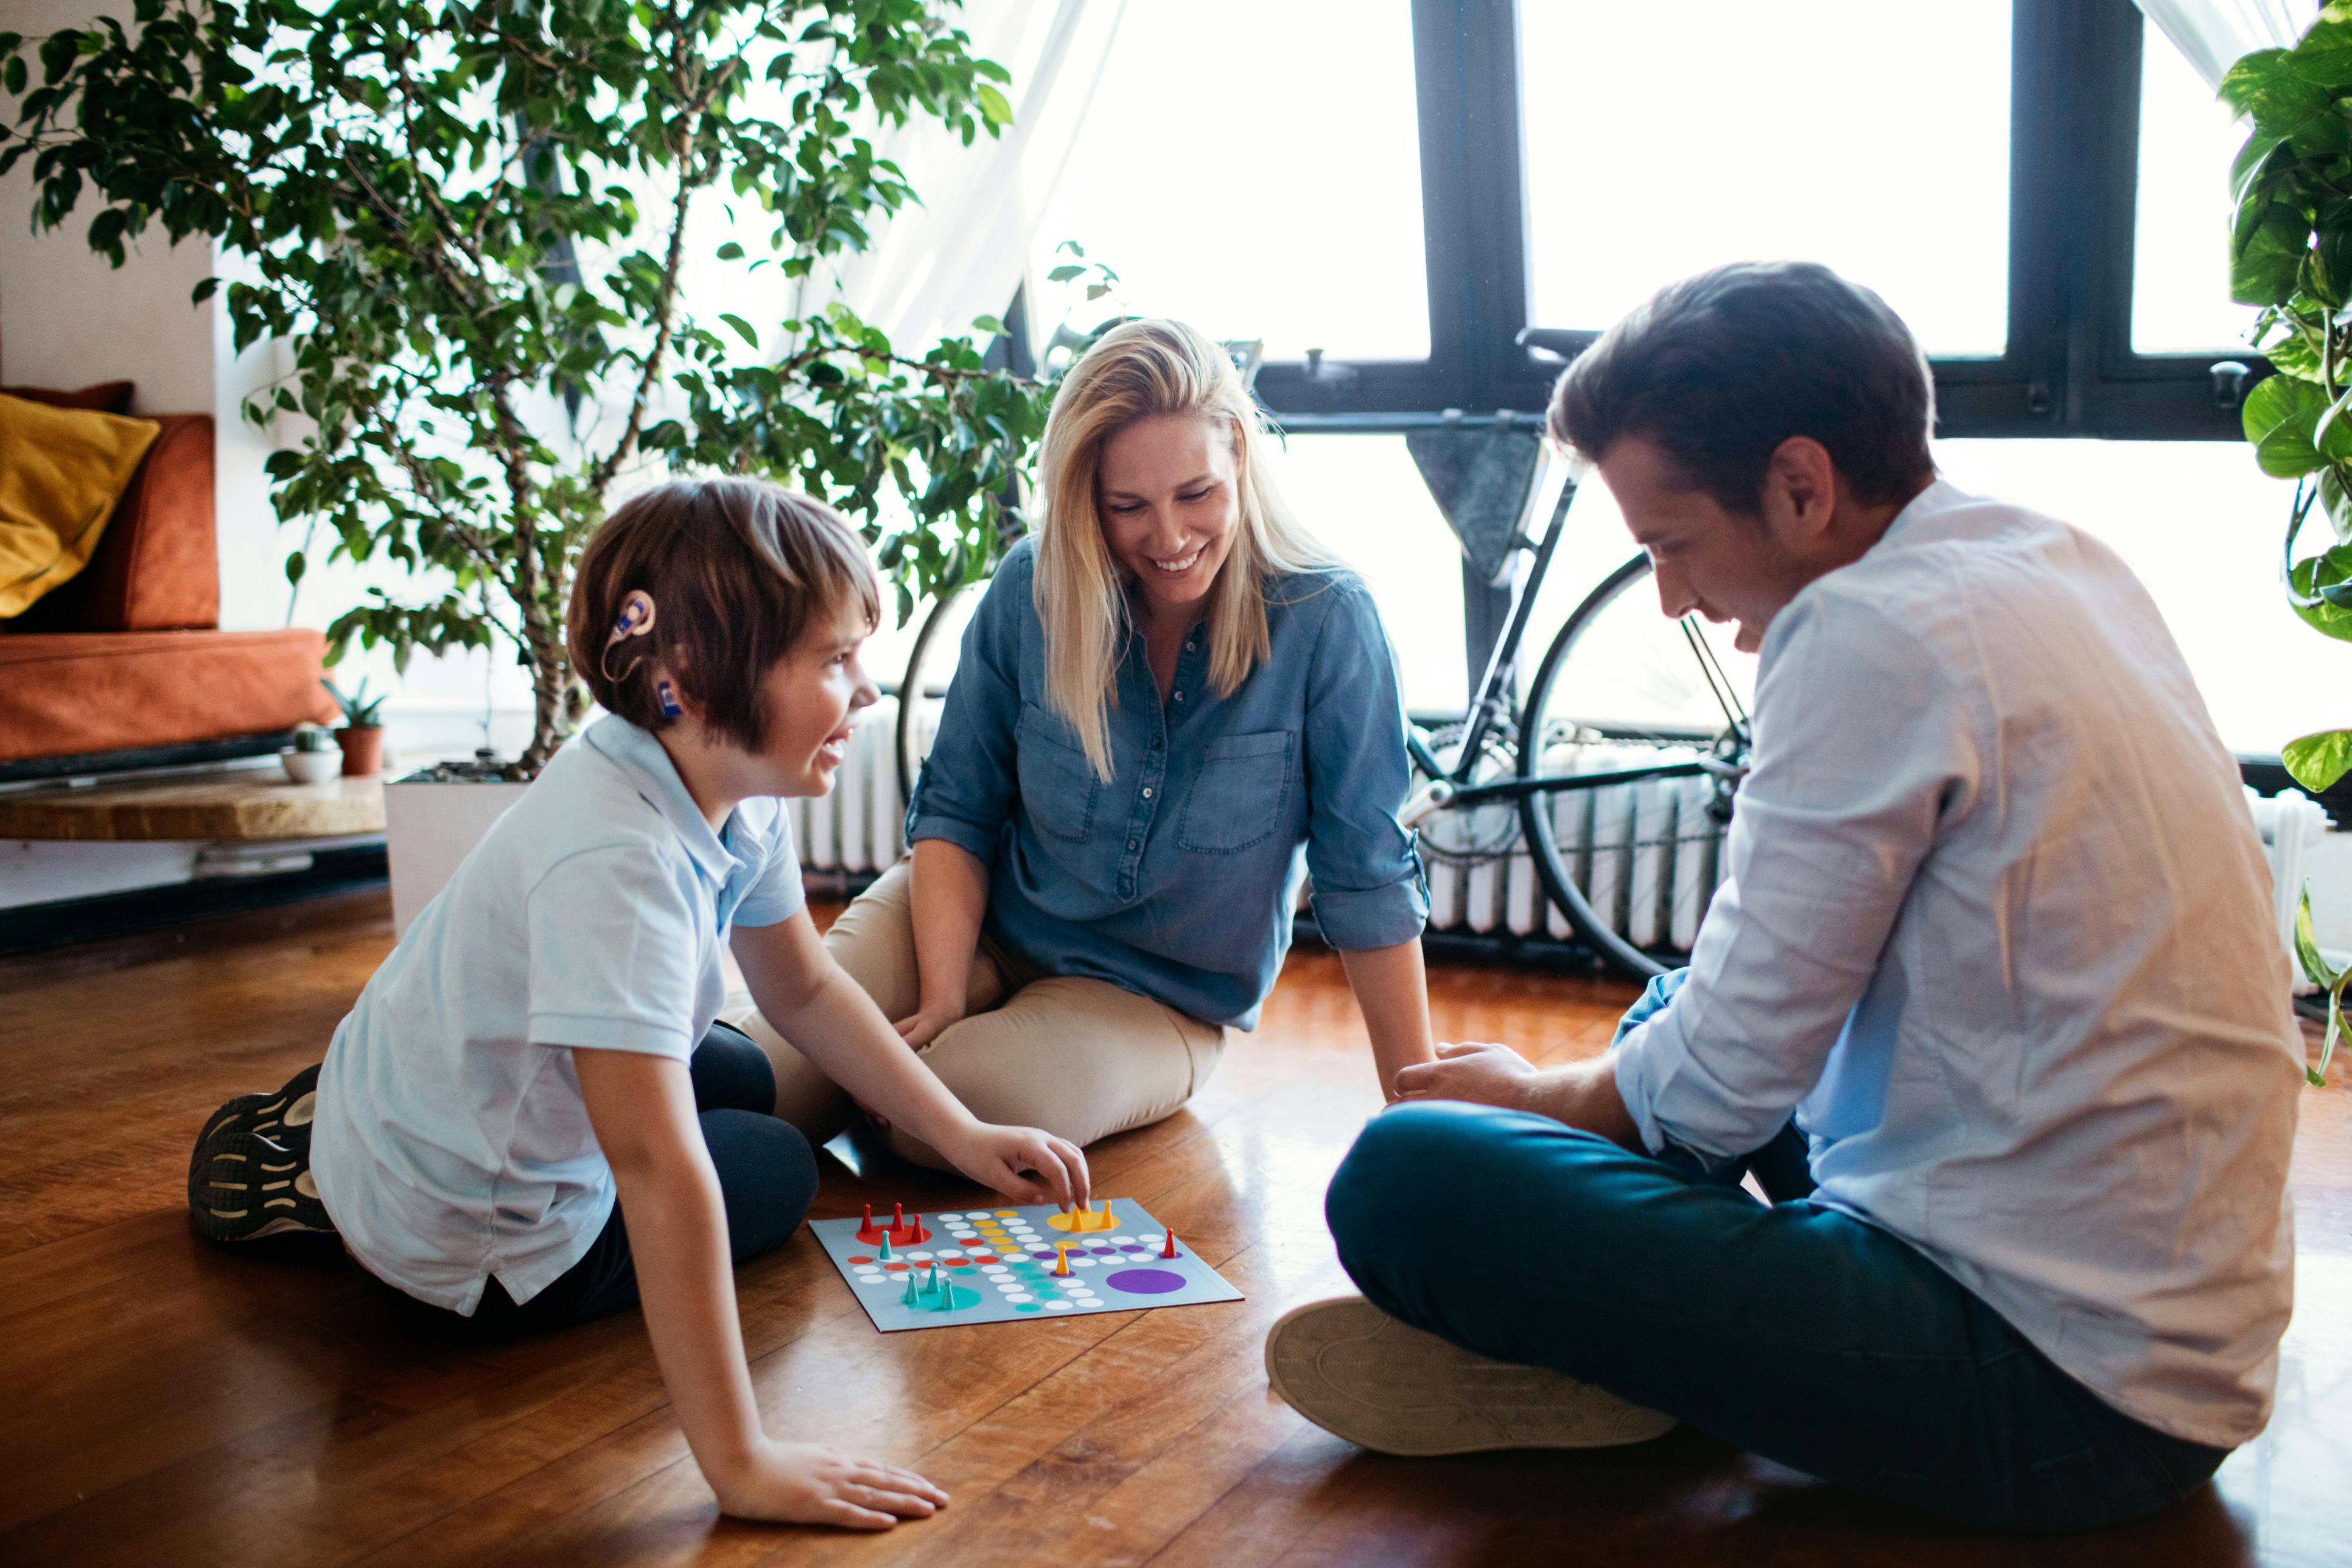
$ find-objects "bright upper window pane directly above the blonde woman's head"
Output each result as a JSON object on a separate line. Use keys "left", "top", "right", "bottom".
{"left": 1032, "top": 0, "right": 1430, "bottom": 360}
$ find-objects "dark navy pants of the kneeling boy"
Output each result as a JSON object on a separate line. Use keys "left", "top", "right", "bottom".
{"left": 463, "top": 1023, "right": 816, "bottom": 1333}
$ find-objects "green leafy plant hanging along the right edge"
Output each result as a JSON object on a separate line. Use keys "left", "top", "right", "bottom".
{"left": 2221, "top": 0, "right": 2352, "bottom": 1083}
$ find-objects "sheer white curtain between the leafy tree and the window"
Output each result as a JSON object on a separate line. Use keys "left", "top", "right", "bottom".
{"left": 797, "top": 0, "right": 1127, "bottom": 352}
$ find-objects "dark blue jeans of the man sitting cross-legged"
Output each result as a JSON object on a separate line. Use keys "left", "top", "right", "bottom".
{"left": 1326, "top": 973, "right": 2227, "bottom": 1530}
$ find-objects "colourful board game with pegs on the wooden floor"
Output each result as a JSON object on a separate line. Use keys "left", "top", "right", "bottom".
{"left": 809, "top": 1199, "right": 1242, "bottom": 1333}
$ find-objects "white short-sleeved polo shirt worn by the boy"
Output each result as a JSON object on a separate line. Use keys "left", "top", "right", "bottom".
{"left": 310, "top": 715, "right": 804, "bottom": 1317}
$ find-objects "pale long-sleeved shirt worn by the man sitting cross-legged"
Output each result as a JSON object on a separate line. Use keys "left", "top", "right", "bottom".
{"left": 1616, "top": 482, "right": 2303, "bottom": 1448}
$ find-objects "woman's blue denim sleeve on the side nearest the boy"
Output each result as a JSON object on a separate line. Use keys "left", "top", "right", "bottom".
{"left": 906, "top": 548, "right": 1030, "bottom": 863}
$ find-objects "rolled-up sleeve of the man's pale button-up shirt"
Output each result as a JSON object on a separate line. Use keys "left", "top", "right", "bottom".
{"left": 1614, "top": 597, "right": 1978, "bottom": 1161}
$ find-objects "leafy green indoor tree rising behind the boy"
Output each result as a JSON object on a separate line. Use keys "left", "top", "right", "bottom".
{"left": 0, "top": 0, "right": 1072, "bottom": 921}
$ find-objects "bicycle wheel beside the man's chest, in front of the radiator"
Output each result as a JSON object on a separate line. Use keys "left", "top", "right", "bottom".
{"left": 1519, "top": 555, "right": 1755, "bottom": 978}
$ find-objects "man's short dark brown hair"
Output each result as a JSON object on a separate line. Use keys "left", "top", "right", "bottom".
{"left": 1550, "top": 261, "right": 1936, "bottom": 515}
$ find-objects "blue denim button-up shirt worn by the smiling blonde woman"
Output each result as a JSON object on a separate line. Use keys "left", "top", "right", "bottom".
{"left": 906, "top": 541, "right": 1430, "bottom": 1030}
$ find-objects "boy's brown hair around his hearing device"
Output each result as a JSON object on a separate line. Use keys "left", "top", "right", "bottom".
{"left": 564, "top": 480, "right": 882, "bottom": 752}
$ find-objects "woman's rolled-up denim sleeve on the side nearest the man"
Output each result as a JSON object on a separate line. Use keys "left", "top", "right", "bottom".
{"left": 1306, "top": 581, "right": 1430, "bottom": 952}
